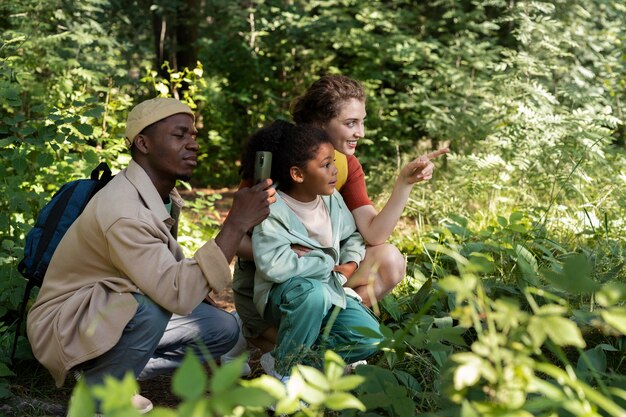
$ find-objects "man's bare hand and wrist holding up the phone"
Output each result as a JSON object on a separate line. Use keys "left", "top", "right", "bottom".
{"left": 215, "top": 179, "right": 276, "bottom": 262}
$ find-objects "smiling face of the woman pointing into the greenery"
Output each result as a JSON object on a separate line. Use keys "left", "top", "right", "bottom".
{"left": 323, "top": 98, "right": 366, "bottom": 155}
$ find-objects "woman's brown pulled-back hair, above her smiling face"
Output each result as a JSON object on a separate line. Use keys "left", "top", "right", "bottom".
{"left": 290, "top": 75, "right": 366, "bottom": 125}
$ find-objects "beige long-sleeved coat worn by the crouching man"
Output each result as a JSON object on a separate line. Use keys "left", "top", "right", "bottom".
{"left": 27, "top": 161, "right": 231, "bottom": 386}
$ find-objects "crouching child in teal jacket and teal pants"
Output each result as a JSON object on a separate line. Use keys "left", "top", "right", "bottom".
{"left": 242, "top": 121, "right": 380, "bottom": 375}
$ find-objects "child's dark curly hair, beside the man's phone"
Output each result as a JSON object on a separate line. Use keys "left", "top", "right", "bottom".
{"left": 240, "top": 120, "right": 332, "bottom": 192}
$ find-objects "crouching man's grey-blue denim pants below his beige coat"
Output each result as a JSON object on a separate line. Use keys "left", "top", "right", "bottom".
{"left": 78, "top": 294, "right": 239, "bottom": 385}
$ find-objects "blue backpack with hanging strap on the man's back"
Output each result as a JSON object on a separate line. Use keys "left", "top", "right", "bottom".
{"left": 11, "top": 162, "right": 113, "bottom": 357}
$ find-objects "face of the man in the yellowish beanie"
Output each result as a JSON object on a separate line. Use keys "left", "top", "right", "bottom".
{"left": 145, "top": 113, "right": 198, "bottom": 181}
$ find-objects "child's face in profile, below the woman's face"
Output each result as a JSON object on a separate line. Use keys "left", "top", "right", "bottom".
{"left": 294, "top": 143, "right": 337, "bottom": 201}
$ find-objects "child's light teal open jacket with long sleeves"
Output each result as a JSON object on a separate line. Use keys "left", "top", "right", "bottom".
{"left": 252, "top": 192, "right": 365, "bottom": 317}
